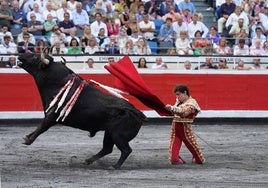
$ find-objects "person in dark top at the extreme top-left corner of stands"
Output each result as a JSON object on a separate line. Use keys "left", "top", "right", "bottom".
{"left": 0, "top": 0, "right": 13, "bottom": 28}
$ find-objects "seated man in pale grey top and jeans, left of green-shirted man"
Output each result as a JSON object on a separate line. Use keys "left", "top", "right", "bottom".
{"left": 28, "top": 13, "right": 44, "bottom": 41}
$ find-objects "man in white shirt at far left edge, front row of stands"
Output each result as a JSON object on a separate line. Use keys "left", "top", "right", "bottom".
{"left": 0, "top": 35, "right": 17, "bottom": 66}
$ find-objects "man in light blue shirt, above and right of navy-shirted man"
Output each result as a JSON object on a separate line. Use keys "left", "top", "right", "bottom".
{"left": 73, "top": 0, "right": 89, "bottom": 30}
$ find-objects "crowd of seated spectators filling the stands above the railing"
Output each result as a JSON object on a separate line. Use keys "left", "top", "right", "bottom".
{"left": 0, "top": 0, "right": 268, "bottom": 68}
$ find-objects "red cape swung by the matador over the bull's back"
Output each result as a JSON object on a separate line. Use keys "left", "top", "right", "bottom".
{"left": 104, "top": 56, "right": 172, "bottom": 116}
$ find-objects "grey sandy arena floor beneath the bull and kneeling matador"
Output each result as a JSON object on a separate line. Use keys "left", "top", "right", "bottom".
{"left": 0, "top": 121, "right": 268, "bottom": 188}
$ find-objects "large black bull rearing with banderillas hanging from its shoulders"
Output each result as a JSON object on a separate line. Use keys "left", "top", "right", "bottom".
{"left": 19, "top": 54, "right": 147, "bottom": 168}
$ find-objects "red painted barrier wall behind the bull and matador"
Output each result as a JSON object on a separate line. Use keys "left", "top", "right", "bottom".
{"left": 0, "top": 72, "right": 268, "bottom": 111}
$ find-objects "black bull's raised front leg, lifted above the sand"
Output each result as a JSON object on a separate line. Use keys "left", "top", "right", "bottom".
{"left": 23, "top": 116, "right": 56, "bottom": 145}
